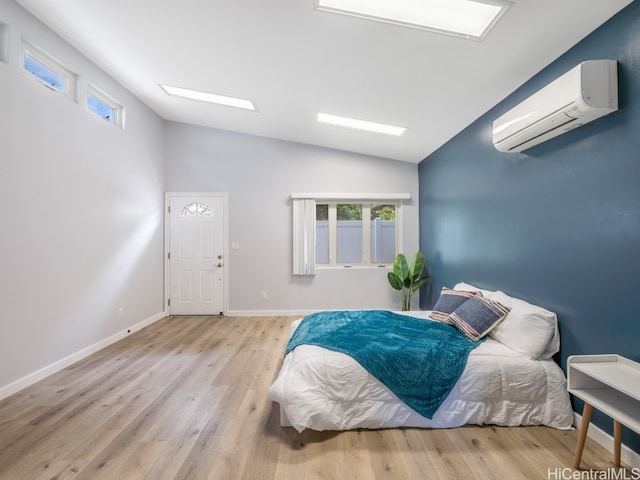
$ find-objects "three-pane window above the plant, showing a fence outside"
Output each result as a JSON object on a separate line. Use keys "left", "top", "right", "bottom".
{"left": 316, "top": 202, "right": 399, "bottom": 267}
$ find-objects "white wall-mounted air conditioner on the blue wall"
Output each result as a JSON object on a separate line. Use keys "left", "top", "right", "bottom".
{"left": 493, "top": 60, "right": 618, "bottom": 152}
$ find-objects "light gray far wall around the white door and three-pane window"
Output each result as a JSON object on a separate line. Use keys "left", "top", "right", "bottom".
{"left": 165, "top": 122, "right": 418, "bottom": 315}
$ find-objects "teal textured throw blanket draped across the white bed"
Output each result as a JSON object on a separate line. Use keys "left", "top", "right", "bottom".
{"left": 286, "top": 310, "right": 481, "bottom": 418}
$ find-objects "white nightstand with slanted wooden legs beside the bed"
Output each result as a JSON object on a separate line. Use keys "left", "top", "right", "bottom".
{"left": 567, "top": 354, "right": 640, "bottom": 468}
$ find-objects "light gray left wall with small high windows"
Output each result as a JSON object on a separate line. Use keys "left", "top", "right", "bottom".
{"left": 0, "top": 0, "right": 164, "bottom": 397}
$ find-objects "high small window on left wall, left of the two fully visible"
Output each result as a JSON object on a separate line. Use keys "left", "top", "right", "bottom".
{"left": 22, "top": 43, "right": 76, "bottom": 100}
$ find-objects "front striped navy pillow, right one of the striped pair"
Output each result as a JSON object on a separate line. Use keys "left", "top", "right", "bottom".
{"left": 449, "top": 295, "right": 511, "bottom": 342}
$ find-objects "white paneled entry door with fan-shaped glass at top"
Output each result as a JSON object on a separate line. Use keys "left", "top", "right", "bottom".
{"left": 167, "top": 194, "right": 225, "bottom": 315}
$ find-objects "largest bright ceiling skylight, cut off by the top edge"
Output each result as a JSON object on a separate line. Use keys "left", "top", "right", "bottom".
{"left": 315, "top": 0, "right": 510, "bottom": 40}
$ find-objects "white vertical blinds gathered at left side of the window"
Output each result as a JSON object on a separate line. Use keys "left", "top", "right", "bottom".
{"left": 293, "top": 198, "right": 316, "bottom": 275}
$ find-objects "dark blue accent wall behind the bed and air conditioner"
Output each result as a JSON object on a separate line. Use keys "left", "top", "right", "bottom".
{"left": 419, "top": 2, "right": 640, "bottom": 452}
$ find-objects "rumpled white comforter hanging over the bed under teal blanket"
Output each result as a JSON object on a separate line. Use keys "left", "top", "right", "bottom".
{"left": 268, "top": 320, "right": 573, "bottom": 431}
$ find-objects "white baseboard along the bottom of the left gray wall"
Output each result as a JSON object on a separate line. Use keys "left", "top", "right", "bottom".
{"left": 0, "top": 312, "right": 166, "bottom": 400}
